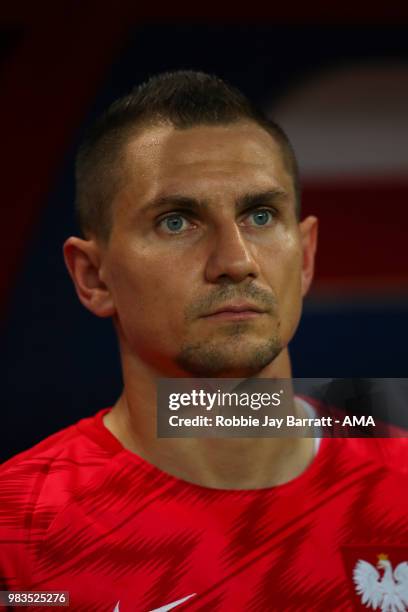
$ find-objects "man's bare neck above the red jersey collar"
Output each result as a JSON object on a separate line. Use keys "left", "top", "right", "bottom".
{"left": 104, "top": 350, "right": 314, "bottom": 489}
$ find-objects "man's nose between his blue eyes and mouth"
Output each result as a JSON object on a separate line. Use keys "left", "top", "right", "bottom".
{"left": 206, "top": 222, "right": 259, "bottom": 283}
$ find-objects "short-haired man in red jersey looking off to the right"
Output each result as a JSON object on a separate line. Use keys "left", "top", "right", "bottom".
{"left": 0, "top": 72, "right": 408, "bottom": 612}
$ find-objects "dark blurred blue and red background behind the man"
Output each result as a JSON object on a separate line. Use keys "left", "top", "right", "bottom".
{"left": 0, "top": 1, "right": 408, "bottom": 460}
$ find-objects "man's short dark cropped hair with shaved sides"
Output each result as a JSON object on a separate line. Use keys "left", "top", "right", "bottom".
{"left": 76, "top": 70, "right": 300, "bottom": 240}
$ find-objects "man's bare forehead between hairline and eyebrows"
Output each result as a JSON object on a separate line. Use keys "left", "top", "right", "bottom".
{"left": 124, "top": 123, "right": 293, "bottom": 200}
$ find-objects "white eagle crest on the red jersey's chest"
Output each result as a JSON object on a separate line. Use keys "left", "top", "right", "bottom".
{"left": 353, "top": 555, "right": 408, "bottom": 612}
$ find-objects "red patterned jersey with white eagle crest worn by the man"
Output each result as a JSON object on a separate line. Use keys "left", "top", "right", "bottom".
{"left": 0, "top": 410, "right": 408, "bottom": 612}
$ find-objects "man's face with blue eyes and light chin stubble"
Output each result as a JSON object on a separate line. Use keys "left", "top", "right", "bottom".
{"left": 101, "top": 123, "right": 316, "bottom": 377}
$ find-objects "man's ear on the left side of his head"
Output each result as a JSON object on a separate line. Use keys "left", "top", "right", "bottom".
{"left": 64, "top": 236, "right": 115, "bottom": 317}
